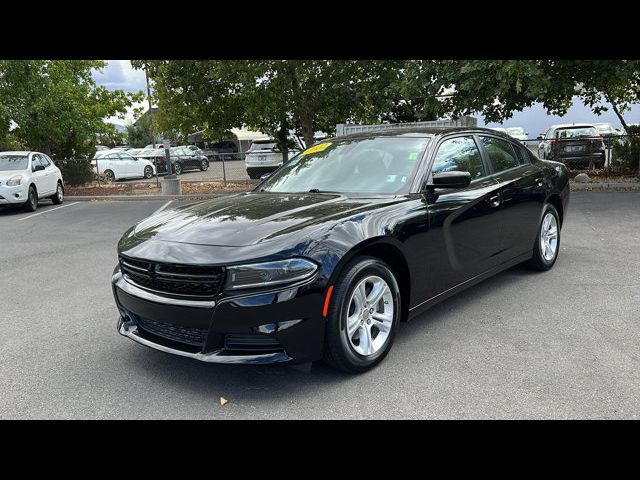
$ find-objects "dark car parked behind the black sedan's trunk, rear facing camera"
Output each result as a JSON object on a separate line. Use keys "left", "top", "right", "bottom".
{"left": 538, "top": 124, "right": 605, "bottom": 167}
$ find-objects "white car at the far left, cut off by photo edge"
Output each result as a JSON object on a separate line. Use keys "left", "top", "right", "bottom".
{"left": 0, "top": 152, "right": 64, "bottom": 212}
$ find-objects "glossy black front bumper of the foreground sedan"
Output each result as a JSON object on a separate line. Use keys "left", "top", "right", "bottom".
{"left": 112, "top": 272, "right": 325, "bottom": 364}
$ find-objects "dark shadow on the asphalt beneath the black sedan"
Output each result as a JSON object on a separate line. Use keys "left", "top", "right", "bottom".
{"left": 116, "top": 266, "right": 534, "bottom": 404}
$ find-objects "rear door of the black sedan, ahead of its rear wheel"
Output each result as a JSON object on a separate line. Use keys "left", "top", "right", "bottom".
{"left": 479, "top": 135, "right": 546, "bottom": 262}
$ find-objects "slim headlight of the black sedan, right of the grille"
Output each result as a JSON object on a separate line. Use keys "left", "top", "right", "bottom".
{"left": 225, "top": 258, "right": 318, "bottom": 290}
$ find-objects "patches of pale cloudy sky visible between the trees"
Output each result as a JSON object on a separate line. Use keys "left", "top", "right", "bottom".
{"left": 93, "top": 60, "right": 640, "bottom": 138}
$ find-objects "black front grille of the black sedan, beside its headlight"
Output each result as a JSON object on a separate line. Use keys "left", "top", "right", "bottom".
{"left": 120, "top": 255, "right": 224, "bottom": 297}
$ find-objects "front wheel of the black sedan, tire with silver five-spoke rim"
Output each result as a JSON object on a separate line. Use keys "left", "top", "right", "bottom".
{"left": 324, "top": 257, "right": 401, "bottom": 373}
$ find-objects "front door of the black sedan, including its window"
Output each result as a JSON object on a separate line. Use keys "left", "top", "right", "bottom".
{"left": 425, "top": 134, "right": 508, "bottom": 299}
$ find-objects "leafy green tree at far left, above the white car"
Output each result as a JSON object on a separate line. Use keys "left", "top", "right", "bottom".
{"left": 0, "top": 60, "right": 141, "bottom": 158}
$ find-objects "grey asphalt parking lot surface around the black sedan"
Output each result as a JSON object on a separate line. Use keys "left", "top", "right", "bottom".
{"left": 0, "top": 192, "right": 640, "bottom": 419}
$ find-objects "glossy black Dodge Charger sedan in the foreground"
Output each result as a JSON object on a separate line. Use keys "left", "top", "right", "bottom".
{"left": 112, "top": 128, "right": 569, "bottom": 372}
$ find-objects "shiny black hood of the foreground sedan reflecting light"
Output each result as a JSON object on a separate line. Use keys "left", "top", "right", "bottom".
{"left": 134, "top": 193, "right": 399, "bottom": 247}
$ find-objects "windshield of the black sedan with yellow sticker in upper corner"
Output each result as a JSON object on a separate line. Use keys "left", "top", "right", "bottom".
{"left": 261, "top": 137, "right": 430, "bottom": 194}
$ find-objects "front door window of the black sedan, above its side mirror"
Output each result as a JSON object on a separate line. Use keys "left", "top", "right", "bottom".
{"left": 431, "top": 137, "right": 486, "bottom": 179}
